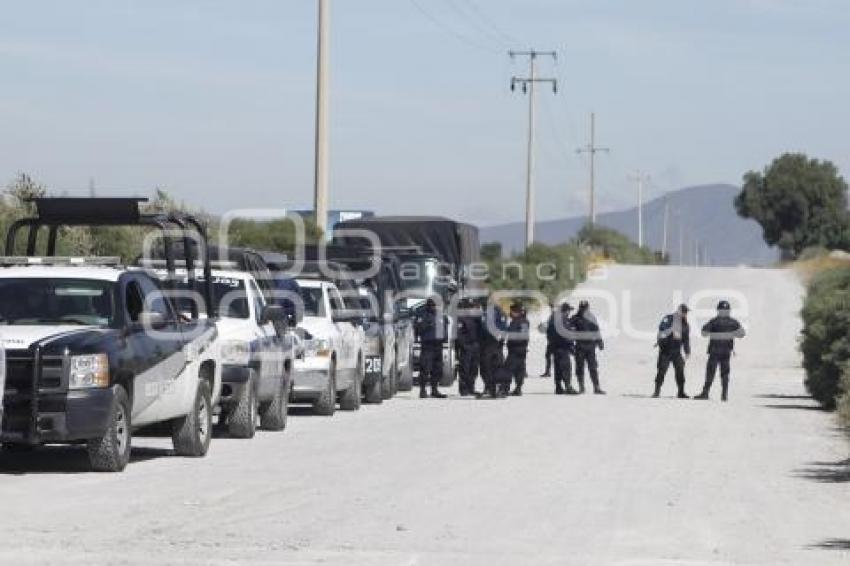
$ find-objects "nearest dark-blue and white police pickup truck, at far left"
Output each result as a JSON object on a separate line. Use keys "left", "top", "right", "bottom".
{"left": 0, "top": 257, "right": 221, "bottom": 471}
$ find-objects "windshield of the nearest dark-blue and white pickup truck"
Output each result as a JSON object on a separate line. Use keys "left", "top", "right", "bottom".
{"left": 0, "top": 278, "right": 115, "bottom": 326}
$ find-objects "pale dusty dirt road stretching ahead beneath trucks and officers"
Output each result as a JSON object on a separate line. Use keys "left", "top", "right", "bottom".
{"left": 0, "top": 267, "right": 850, "bottom": 565}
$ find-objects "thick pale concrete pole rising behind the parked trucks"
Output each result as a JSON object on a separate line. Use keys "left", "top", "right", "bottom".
{"left": 313, "top": 0, "right": 330, "bottom": 234}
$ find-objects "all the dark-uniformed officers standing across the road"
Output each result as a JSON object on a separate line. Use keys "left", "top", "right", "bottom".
{"left": 414, "top": 298, "right": 745, "bottom": 401}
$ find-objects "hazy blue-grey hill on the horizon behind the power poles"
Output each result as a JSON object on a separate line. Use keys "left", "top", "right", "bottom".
{"left": 481, "top": 185, "right": 779, "bottom": 266}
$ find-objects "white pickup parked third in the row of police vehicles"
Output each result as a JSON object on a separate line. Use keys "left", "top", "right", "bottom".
{"left": 292, "top": 278, "right": 365, "bottom": 416}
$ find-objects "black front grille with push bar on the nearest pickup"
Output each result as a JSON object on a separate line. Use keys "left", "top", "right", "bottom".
{"left": 2, "top": 348, "right": 64, "bottom": 442}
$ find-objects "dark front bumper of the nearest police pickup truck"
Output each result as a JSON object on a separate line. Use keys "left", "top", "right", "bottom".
{"left": 0, "top": 388, "right": 115, "bottom": 444}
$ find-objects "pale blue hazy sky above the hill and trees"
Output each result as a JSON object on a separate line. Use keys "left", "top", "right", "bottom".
{"left": 0, "top": 0, "right": 850, "bottom": 224}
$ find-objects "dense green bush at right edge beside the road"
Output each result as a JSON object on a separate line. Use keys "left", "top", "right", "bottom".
{"left": 800, "top": 267, "right": 850, "bottom": 409}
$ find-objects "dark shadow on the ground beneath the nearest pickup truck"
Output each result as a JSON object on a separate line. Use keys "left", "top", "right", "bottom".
{"left": 0, "top": 446, "right": 174, "bottom": 476}
